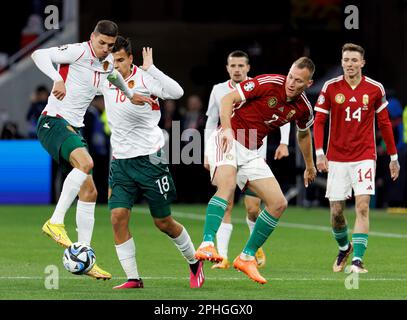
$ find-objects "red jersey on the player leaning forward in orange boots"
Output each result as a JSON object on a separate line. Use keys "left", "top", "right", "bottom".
{"left": 231, "top": 74, "right": 314, "bottom": 149}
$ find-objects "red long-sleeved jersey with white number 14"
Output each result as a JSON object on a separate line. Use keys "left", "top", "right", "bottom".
{"left": 314, "top": 76, "right": 397, "bottom": 162}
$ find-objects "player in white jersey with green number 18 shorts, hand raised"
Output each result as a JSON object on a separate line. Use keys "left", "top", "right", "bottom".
{"left": 102, "top": 36, "right": 204, "bottom": 289}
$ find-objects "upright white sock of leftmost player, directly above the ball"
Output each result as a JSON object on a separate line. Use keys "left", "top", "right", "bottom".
{"left": 76, "top": 200, "right": 96, "bottom": 245}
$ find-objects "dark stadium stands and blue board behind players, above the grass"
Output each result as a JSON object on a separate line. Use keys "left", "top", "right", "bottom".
{"left": 0, "top": 0, "right": 407, "bottom": 208}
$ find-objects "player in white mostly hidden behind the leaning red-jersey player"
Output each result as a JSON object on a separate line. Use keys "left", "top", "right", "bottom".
{"left": 204, "top": 50, "right": 290, "bottom": 269}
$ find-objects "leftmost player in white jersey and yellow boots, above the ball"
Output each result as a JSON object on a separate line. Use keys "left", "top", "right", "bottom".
{"left": 32, "top": 20, "right": 152, "bottom": 280}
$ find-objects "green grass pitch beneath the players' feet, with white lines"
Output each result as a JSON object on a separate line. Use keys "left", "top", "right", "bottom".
{"left": 0, "top": 205, "right": 407, "bottom": 300}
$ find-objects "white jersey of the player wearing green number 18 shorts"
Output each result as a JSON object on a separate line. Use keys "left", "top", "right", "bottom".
{"left": 102, "top": 65, "right": 183, "bottom": 159}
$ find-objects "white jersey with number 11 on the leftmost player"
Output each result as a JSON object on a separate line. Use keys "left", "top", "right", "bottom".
{"left": 43, "top": 41, "right": 114, "bottom": 127}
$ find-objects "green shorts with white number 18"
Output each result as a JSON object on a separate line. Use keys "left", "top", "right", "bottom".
{"left": 109, "top": 151, "right": 176, "bottom": 218}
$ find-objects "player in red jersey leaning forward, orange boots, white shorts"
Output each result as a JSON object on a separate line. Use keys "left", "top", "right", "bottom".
{"left": 195, "top": 57, "right": 316, "bottom": 284}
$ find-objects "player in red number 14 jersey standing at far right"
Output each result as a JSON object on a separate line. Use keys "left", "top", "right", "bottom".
{"left": 314, "top": 43, "right": 400, "bottom": 273}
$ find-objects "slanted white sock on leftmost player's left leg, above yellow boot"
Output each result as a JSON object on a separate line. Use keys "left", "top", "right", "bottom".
{"left": 50, "top": 168, "right": 88, "bottom": 224}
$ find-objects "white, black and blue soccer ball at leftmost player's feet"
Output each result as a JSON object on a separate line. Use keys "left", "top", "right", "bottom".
{"left": 62, "top": 242, "right": 96, "bottom": 274}
